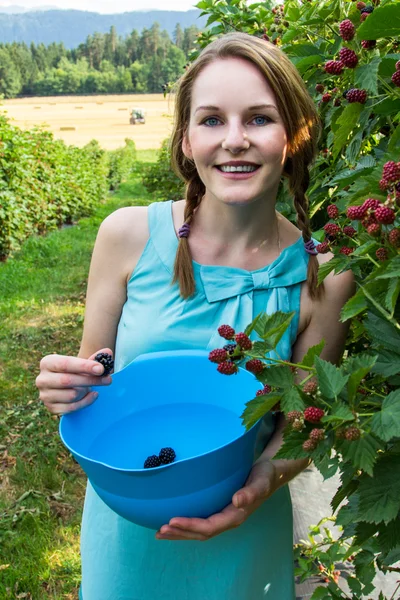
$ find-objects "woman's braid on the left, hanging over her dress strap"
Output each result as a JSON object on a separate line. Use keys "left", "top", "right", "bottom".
{"left": 172, "top": 172, "right": 205, "bottom": 298}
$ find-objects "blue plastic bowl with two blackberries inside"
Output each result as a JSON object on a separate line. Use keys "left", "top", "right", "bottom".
{"left": 60, "top": 350, "right": 261, "bottom": 529}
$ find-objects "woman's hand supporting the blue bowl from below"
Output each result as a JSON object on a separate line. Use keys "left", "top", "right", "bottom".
{"left": 156, "top": 458, "right": 280, "bottom": 542}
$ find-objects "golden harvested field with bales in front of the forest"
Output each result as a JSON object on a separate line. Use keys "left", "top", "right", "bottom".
{"left": 0, "top": 94, "right": 174, "bottom": 150}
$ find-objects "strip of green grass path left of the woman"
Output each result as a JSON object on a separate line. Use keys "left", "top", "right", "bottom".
{"left": 0, "top": 150, "right": 157, "bottom": 600}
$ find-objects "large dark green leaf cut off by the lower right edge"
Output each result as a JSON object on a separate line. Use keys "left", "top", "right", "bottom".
{"left": 359, "top": 455, "right": 400, "bottom": 523}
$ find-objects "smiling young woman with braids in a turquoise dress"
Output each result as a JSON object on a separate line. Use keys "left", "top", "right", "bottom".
{"left": 37, "top": 33, "right": 353, "bottom": 600}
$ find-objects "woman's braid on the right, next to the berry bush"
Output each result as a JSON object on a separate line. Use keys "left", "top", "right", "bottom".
{"left": 289, "top": 166, "right": 324, "bottom": 300}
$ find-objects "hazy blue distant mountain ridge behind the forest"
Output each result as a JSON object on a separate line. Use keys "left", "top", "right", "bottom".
{"left": 0, "top": 7, "right": 207, "bottom": 48}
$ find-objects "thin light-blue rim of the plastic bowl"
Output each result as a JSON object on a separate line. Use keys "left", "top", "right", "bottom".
{"left": 58, "top": 350, "right": 263, "bottom": 474}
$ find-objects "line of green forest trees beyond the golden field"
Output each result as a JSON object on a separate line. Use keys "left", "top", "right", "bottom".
{"left": 0, "top": 23, "right": 199, "bottom": 98}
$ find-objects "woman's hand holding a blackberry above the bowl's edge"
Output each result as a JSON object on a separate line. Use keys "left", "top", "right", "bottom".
{"left": 36, "top": 348, "right": 112, "bottom": 415}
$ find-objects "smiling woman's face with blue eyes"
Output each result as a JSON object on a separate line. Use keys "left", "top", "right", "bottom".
{"left": 182, "top": 58, "right": 287, "bottom": 209}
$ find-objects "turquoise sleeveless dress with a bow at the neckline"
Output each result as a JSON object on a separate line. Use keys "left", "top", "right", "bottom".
{"left": 80, "top": 201, "right": 308, "bottom": 600}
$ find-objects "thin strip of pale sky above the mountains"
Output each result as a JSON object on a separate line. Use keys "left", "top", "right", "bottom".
{"left": 0, "top": 0, "right": 198, "bottom": 14}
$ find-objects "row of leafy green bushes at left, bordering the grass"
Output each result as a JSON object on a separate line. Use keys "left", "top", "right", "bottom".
{"left": 0, "top": 115, "right": 135, "bottom": 260}
